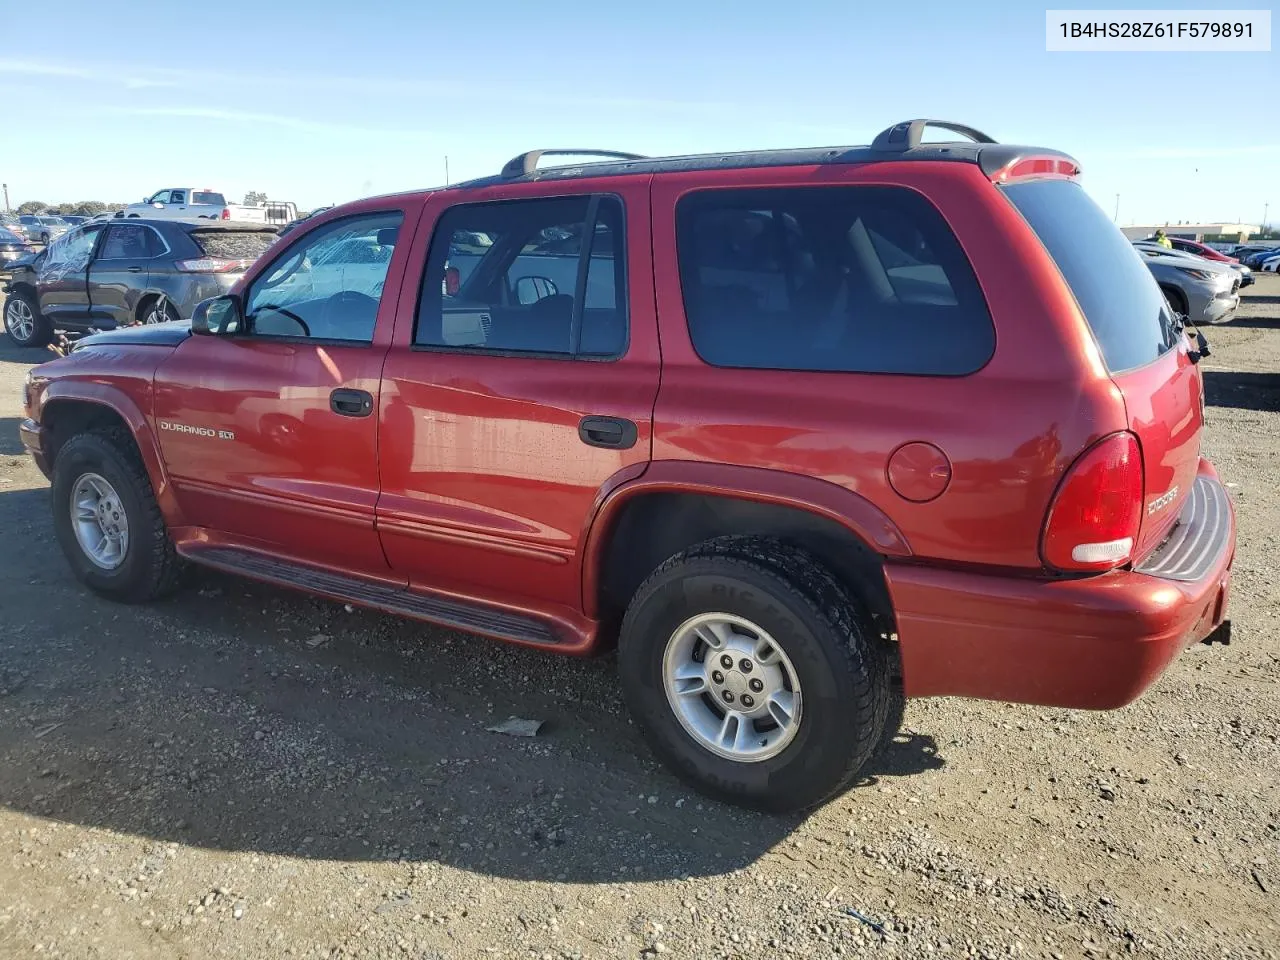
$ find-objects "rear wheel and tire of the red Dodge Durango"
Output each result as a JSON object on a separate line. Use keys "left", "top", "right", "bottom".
{"left": 618, "top": 538, "right": 892, "bottom": 813}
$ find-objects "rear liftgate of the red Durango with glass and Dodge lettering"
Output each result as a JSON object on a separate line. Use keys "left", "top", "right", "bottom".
{"left": 1001, "top": 179, "right": 1203, "bottom": 559}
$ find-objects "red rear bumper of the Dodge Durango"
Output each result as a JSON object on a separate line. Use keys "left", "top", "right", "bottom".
{"left": 886, "top": 461, "right": 1235, "bottom": 709}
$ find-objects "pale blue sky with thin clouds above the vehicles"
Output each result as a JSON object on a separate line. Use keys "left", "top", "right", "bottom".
{"left": 0, "top": 0, "right": 1280, "bottom": 224}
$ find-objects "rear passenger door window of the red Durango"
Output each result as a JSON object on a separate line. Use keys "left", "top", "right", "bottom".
{"left": 415, "top": 197, "right": 627, "bottom": 357}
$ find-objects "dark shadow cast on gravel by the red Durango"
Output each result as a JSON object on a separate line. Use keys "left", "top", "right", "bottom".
{"left": 0, "top": 490, "right": 943, "bottom": 883}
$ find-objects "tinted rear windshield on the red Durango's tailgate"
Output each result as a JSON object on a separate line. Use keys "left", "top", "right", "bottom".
{"left": 1004, "top": 180, "right": 1178, "bottom": 374}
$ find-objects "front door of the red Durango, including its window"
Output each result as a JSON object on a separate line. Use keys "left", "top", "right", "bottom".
{"left": 155, "top": 206, "right": 416, "bottom": 575}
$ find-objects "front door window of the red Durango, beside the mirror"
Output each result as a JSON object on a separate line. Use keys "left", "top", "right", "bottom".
{"left": 240, "top": 212, "right": 403, "bottom": 343}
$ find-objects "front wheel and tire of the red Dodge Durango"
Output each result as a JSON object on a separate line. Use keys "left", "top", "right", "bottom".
{"left": 52, "top": 429, "right": 182, "bottom": 603}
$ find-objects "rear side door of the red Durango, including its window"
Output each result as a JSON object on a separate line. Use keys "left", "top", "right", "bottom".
{"left": 378, "top": 177, "right": 659, "bottom": 612}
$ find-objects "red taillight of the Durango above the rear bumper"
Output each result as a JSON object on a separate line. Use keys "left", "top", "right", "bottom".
{"left": 1041, "top": 433, "right": 1142, "bottom": 571}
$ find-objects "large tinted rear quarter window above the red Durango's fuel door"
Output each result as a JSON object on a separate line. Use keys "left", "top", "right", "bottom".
{"left": 676, "top": 187, "right": 996, "bottom": 376}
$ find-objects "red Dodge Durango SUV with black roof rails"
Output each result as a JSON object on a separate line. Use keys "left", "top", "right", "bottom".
{"left": 22, "top": 120, "right": 1235, "bottom": 809}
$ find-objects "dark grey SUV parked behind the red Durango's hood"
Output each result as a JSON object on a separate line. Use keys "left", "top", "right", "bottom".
{"left": 4, "top": 220, "right": 275, "bottom": 347}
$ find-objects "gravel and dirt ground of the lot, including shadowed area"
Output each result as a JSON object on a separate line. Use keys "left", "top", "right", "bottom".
{"left": 0, "top": 276, "right": 1280, "bottom": 960}
